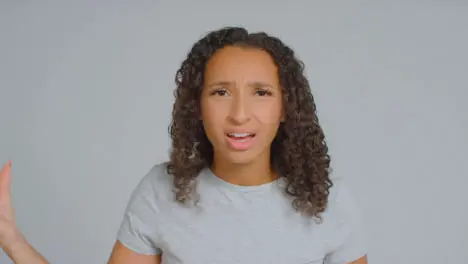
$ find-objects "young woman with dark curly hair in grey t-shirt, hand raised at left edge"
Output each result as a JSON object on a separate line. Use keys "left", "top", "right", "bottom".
{"left": 0, "top": 28, "right": 367, "bottom": 264}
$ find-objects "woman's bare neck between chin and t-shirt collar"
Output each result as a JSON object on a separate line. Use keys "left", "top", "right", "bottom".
{"left": 211, "top": 151, "right": 278, "bottom": 186}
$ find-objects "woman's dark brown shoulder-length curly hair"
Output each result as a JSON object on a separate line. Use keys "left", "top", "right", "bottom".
{"left": 167, "top": 27, "right": 333, "bottom": 219}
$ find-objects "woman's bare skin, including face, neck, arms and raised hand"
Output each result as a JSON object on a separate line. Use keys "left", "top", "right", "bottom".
{"left": 0, "top": 47, "right": 367, "bottom": 264}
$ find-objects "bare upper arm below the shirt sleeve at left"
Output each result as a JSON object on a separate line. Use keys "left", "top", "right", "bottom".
{"left": 108, "top": 241, "right": 161, "bottom": 264}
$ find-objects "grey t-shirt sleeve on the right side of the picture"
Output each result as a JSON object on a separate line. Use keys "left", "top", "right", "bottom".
{"left": 325, "top": 181, "right": 368, "bottom": 264}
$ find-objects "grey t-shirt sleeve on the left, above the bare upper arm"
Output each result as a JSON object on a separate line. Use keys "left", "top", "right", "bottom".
{"left": 117, "top": 167, "right": 162, "bottom": 255}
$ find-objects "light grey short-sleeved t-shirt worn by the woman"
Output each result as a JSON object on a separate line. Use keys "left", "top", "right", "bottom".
{"left": 117, "top": 164, "right": 367, "bottom": 264}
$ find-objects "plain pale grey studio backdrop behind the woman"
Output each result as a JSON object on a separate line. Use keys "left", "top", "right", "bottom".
{"left": 0, "top": 0, "right": 468, "bottom": 264}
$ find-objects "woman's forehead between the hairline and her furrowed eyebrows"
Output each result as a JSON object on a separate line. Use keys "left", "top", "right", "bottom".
{"left": 205, "top": 47, "right": 278, "bottom": 83}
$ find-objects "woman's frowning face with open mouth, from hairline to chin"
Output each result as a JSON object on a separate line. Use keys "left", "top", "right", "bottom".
{"left": 201, "top": 47, "right": 283, "bottom": 164}
